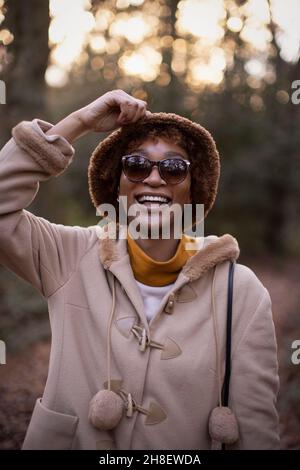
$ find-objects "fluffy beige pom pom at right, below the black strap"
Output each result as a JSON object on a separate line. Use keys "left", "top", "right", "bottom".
{"left": 208, "top": 406, "right": 239, "bottom": 444}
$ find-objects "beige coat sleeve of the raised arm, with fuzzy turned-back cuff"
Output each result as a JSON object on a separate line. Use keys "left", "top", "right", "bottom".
{"left": 0, "top": 120, "right": 95, "bottom": 297}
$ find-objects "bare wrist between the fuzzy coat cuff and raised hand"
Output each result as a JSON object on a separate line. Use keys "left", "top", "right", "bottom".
{"left": 46, "top": 110, "right": 89, "bottom": 144}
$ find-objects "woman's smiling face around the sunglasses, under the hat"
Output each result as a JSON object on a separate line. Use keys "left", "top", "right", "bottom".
{"left": 119, "top": 138, "right": 191, "bottom": 237}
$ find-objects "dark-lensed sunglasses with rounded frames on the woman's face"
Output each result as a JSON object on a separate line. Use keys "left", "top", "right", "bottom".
{"left": 122, "top": 154, "right": 191, "bottom": 184}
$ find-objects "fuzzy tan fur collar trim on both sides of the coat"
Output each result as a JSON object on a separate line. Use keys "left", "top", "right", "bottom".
{"left": 99, "top": 226, "right": 240, "bottom": 281}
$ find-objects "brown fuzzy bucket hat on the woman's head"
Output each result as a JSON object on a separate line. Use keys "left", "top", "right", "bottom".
{"left": 88, "top": 113, "right": 220, "bottom": 220}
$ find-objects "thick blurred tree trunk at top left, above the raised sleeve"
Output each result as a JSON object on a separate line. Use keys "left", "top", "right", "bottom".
{"left": 0, "top": 0, "right": 50, "bottom": 144}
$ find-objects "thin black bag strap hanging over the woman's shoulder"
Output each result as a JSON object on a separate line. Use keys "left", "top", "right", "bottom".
{"left": 222, "top": 261, "right": 235, "bottom": 450}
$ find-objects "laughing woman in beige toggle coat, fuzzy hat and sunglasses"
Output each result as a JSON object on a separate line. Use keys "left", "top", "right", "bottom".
{"left": 0, "top": 90, "right": 279, "bottom": 449}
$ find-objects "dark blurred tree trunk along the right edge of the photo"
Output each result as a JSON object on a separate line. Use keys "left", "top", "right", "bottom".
{"left": 263, "top": 0, "right": 300, "bottom": 254}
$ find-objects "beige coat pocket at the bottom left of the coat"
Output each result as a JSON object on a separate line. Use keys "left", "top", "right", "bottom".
{"left": 22, "top": 398, "right": 79, "bottom": 450}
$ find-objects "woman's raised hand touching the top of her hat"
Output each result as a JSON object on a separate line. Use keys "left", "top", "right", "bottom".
{"left": 76, "top": 90, "right": 150, "bottom": 132}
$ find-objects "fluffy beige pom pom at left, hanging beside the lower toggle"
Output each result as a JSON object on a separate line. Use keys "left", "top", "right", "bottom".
{"left": 89, "top": 390, "right": 124, "bottom": 431}
